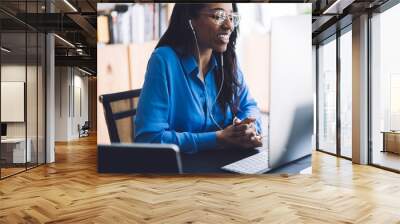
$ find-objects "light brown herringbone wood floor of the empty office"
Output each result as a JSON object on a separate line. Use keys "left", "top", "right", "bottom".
{"left": 0, "top": 134, "right": 400, "bottom": 224}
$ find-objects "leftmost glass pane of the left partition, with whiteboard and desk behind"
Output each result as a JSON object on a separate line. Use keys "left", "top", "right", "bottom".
{"left": 0, "top": 23, "right": 27, "bottom": 178}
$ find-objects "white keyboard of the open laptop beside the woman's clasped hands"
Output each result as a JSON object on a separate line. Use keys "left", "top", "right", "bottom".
{"left": 222, "top": 150, "right": 269, "bottom": 174}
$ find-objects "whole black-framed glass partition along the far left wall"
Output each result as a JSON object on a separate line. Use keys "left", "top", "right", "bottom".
{"left": 0, "top": 1, "right": 46, "bottom": 178}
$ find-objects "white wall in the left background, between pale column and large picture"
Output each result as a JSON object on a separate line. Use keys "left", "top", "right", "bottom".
{"left": 55, "top": 67, "right": 88, "bottom": 141}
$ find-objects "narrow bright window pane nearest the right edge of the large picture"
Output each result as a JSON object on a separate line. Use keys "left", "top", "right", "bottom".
{"left": 318, "top": 40, "right": 336, "bottom": 153}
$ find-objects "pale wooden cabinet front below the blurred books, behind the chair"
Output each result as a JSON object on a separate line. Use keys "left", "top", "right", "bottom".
{"left": 97, "top": 41, "right": 157, "bottom": 144}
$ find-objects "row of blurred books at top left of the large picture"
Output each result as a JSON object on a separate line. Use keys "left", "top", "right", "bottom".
{"left": 97, "top": 3, "right": 174, "bottom": 44}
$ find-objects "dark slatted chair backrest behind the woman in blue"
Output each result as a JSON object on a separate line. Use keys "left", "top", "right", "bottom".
{"left": 99, "top": 89, "right": 141, "bottom": 143}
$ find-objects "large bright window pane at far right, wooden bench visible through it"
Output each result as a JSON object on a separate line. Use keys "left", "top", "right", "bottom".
{"left": 371, "top": 4, "right": 400, "bottom": 170}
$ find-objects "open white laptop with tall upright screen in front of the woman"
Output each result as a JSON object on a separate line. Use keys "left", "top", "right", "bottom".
{"left": 223, "top": 15, "right": 315, "bottom": 174}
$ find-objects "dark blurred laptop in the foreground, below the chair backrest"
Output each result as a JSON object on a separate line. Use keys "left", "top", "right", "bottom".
{"left": 97, "top": 143, "right": 183, "bottom": 174}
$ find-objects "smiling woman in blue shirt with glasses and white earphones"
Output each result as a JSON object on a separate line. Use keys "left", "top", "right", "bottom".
{"left": 135, "top": 3, "right": 262, "bottom": 153}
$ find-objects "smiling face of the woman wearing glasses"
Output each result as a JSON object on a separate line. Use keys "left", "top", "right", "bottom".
{"left": 192, "top": 3, "right": 234, "bottom": 52}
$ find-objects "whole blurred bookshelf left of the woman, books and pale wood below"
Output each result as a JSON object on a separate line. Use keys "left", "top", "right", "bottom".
{"left": 97, "top": 3, "right": 170, "bottom": 144}
